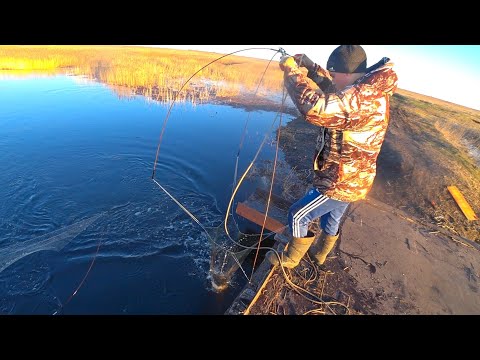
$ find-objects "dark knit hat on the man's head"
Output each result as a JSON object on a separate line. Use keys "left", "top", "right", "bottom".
{"left": 327, "top": 45, "right": 367, "bottom": 74}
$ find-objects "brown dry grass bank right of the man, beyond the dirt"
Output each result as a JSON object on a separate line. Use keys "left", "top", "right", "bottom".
{"left": 380, "top": 92, "right": 480, "bottom": 241}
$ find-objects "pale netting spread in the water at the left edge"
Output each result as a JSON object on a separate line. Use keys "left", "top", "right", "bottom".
{"left": 0, "top": 213, "right": 103, "bottom": 272}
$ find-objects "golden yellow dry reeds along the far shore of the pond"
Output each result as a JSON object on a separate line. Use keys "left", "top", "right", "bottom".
{"left": 0, "top": 46, "right": 283, "bottom": 101}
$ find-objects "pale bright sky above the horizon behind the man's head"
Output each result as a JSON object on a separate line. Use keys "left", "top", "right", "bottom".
{"left": 144, "top": 45, "right": 480, "bottom": 110}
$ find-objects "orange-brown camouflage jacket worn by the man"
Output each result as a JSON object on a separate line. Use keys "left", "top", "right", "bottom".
{"left": 285, "top": 58, "right": 398, "bottom": 202}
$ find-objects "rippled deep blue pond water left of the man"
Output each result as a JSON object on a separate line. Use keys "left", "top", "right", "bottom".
{"left": 0, "top": 75, "right": 286, "bottom": 314}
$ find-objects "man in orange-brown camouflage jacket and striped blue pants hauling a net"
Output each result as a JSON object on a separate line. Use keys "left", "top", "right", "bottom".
{"left": 267, "top": 45, "right": 398, "bottom": 268}
